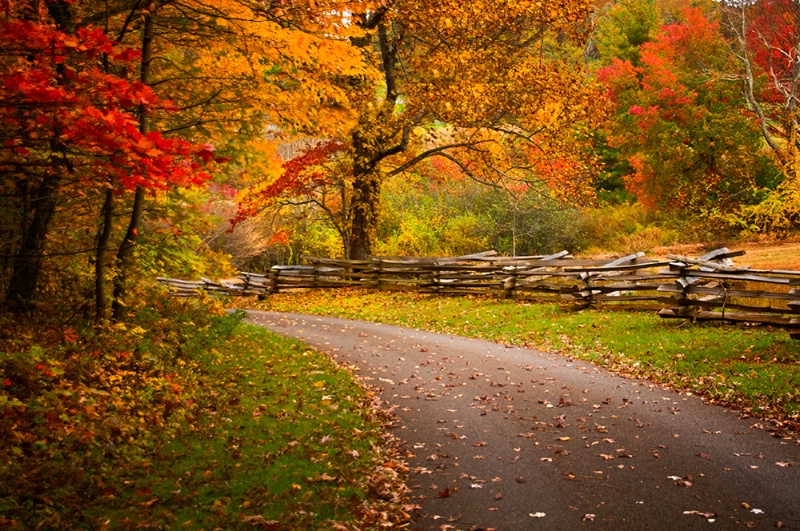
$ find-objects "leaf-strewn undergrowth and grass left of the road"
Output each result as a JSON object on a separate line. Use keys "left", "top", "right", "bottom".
{"left": 0, "top": 294, "right": 407, "bottom": 530}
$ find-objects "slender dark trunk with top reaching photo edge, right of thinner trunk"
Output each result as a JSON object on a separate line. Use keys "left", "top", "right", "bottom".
{"left": 111, "top": 2, "right": 157, "bottom": 320}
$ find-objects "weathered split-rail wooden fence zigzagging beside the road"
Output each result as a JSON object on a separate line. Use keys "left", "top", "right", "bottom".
{"left": 158, "top": 248, "right": 800, "bottom": 339}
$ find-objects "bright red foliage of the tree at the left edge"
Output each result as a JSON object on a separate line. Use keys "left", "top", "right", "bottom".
{"left": 0, "top": 20, "right": 218, "bottom": 194}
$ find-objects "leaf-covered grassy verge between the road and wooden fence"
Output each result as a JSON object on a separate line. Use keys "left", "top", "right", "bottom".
{"left": 248, "top": 290, "right": 800, "bottom": 428}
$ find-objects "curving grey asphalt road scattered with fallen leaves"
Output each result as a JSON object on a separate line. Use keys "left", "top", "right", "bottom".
{"left": 242, "top": 311, "right": 800, "bottom": 531}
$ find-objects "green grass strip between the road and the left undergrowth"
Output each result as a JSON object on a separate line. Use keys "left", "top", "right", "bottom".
{"left": 90, "top": 326, "right": 404, "bottom": 529}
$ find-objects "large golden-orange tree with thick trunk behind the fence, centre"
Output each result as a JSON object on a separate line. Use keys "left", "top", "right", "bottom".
{"left": 241, "top": 0, "right": 603, "bottom": 258}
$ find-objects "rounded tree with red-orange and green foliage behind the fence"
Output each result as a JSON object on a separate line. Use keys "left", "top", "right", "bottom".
{"left": 599, "top": 9, "right": 770, "bottom": 215}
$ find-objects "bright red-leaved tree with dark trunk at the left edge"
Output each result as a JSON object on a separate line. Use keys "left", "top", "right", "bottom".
{"left": 0, "top": 2, "right": 216, "bottom": 311}
